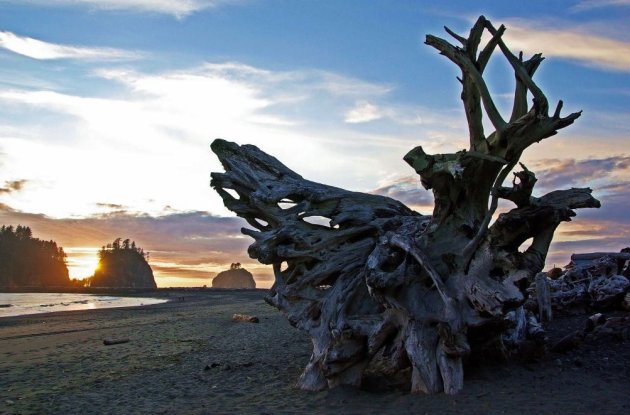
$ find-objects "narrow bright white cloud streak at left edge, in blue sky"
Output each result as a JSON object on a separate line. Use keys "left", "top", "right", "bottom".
{"left": 0, "top": 32, "right": 142, "bottom": 61}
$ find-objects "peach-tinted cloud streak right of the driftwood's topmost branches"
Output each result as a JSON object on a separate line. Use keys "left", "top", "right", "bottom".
{"left": 504, "top": 19, "right": 630, "bottom": 72}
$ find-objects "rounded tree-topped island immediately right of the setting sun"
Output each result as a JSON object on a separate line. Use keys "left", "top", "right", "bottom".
{"left": 86, "top": 238, "right": 157, "bottom": 288}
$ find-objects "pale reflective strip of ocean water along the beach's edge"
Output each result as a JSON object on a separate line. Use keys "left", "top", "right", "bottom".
{"left": 0, "top": 293, "right": 167, "bottom": 317}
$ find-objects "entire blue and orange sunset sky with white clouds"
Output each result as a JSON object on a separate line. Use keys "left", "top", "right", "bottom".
{"left": 0, "top": 0, "right": 630, "bottom": 287}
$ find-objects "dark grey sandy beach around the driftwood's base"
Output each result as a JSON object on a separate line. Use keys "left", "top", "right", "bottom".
{"left": 0, "top": 290, "right": 630, "bottom": 414}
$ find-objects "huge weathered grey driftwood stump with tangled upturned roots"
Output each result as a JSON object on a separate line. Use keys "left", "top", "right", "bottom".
{"left": 211, "top": 16, "right": 600, "bottom": 394}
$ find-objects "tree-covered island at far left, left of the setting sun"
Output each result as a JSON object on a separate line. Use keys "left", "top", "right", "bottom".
{"left": 0, "top": 225, "right": 70, "bottom": 288}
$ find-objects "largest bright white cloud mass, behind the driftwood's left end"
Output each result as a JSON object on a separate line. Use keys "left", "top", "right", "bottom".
{"left": 0, "top": 62, "right": 464, "bottom": 217}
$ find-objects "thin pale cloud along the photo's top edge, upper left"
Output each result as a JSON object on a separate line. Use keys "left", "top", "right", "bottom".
{"left": 3, "top": 0, "right": 246, "bottom": 18}
